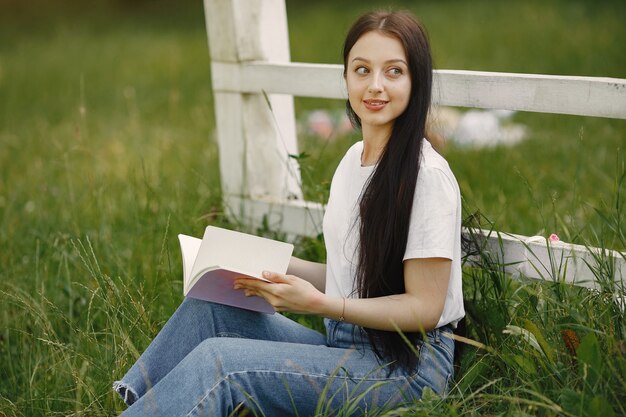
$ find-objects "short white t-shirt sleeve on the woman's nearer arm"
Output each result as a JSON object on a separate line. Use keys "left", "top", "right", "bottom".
{"left": 403, "top": 166, "right": 461, "bottom": 260}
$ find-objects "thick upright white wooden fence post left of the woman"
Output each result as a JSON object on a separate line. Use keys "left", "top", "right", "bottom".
{"left": 204, "top": 0, "right": 302, "bottom": 217}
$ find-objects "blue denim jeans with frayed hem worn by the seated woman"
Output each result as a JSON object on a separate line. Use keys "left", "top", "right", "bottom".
{"left": 113, "top": 298, "right": 454, "bottom": 417}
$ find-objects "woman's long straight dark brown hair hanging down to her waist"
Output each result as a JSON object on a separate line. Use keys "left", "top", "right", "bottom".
{"left": 343, "top": 12, "right": 432, "bottom": 370}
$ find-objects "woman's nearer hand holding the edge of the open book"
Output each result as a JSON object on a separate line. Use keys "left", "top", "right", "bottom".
{"left": 234, "top": 271, "right": 324, "bottom": 314}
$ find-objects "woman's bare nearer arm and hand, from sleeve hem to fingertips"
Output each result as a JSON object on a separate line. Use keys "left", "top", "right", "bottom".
{"left": 235, "top": 258, "right": 452, "bottom": 332}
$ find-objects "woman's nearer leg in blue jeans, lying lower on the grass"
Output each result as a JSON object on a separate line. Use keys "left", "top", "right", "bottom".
{"left": 118, "top": 323, "right": 453, "bottom": 417}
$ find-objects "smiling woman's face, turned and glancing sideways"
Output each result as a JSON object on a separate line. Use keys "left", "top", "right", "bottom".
{"left": 346, "top": 31, "right": 411, "bottom": 136}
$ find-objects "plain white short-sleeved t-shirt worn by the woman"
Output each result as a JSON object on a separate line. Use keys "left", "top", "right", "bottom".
{"left": 324, "top": 140, "right": 465, "bottom": 327}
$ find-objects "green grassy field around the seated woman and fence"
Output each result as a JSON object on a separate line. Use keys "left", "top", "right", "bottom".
{"left": 0, "top": 0, "right": 626, "bottom": 417}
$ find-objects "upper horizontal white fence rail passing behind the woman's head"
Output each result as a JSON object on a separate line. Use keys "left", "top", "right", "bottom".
{"left": 212, "top": 62, "right": 626, "bottom": 119}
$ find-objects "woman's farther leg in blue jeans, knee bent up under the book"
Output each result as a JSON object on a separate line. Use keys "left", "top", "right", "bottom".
{"left": 113, "top": 298, "right": 325, "bottom": 405}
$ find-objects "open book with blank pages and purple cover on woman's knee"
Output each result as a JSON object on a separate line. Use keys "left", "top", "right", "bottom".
{"left": 178, "top": 226, "right": 293, "bottom": 313}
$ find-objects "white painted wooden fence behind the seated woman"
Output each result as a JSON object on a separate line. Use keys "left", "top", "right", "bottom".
{"left": 204, "top": 0, "right": 626, "bottom": 287}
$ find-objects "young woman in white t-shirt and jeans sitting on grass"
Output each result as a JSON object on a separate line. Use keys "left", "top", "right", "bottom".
{"left": 114, "top": 13, "right": 464, "bottom": 416}
